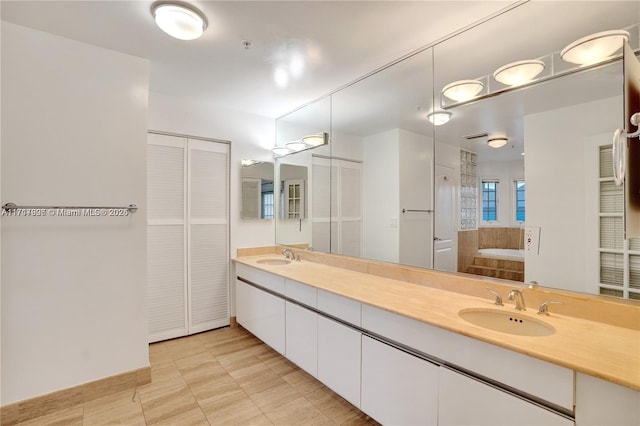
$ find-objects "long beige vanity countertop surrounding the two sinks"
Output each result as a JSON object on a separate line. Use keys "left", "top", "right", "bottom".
{"left": 234, "top": 254, "right": 640, "bottom": 391}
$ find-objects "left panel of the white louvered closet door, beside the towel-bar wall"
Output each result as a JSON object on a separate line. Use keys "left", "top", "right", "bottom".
{"left": 147, "top": 133, "right": 187, "bottom": 342}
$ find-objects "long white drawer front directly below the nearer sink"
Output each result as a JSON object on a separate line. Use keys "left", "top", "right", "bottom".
{"left": 362, "top": 304, "right": 574, "bottom": 411}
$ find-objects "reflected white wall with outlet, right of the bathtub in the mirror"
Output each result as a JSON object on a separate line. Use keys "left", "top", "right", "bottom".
{"left": 524, "top": 97, "right": 622, "bottom": 292}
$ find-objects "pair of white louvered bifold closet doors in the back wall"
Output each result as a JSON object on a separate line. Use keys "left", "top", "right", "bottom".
{"left": 147, "top": 133, "right": 229, "bottom": 342}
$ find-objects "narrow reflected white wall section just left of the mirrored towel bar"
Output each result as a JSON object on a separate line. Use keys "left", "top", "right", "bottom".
{"left": 362, "top": 129, "right": 400, "bottom": 263}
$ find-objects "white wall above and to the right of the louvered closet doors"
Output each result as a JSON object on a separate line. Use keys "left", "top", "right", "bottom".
{"left": 149, "top": 92, "right": 275, "bottom": 256}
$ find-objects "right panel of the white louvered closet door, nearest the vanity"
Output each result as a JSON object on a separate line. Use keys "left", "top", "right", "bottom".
{"left": 187, "top": 139, "right": 229, "bottom": 334}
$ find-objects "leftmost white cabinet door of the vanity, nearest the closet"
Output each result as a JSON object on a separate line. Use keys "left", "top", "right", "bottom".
{"left": 236, "top": 280, "right": 285, "bottom": 355}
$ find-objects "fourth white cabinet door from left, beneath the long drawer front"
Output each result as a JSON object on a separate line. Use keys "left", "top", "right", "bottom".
{"left": 362, "top": 336, "right": 438, "bottom": 425}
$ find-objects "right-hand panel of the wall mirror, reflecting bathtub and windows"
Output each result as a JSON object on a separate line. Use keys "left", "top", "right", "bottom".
{"left": 434, "top": 2, "right": 640, "bottom": 298}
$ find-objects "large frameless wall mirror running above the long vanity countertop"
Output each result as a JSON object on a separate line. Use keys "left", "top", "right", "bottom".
{"left": 276, "top": 1, "right": 640, "bottom": 299}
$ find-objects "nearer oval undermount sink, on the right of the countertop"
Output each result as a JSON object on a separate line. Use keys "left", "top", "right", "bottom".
{"left": 458, "top": 308, "right": 556, "bottom": 337}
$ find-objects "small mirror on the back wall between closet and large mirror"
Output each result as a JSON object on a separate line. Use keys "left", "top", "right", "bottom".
{"left": 240, "top": 160, "right": 275, "bottom": 220}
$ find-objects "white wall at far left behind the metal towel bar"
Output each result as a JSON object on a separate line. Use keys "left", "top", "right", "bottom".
{"left": 1, "top": 22, "right": 149, "bottom": 404}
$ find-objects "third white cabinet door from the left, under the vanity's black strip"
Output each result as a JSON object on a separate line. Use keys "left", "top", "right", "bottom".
{"left": 318, "top": 316, "right": 361, "bottom": 407}
